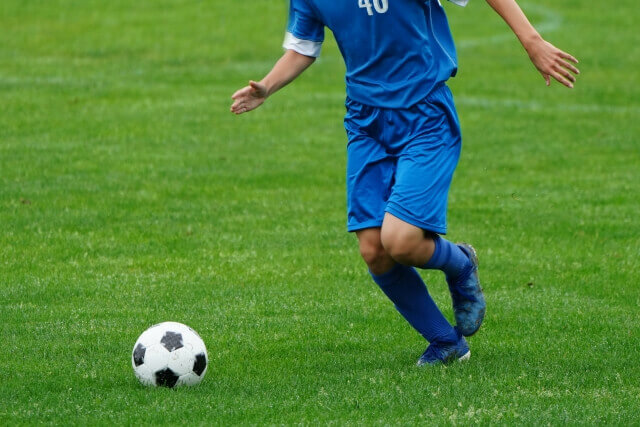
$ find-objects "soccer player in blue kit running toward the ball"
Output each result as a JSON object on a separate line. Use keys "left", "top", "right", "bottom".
{"left": 231, "top": 0, "right": 579, "bottom": 365}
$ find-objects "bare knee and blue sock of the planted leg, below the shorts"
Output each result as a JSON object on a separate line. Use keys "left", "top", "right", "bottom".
{"left": 356, "top": 228, "right": 468, "bottom": 354}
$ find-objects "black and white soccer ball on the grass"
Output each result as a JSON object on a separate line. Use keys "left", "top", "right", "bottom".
{"left": 131, "top": 322, "right": 208, "bottom": 387}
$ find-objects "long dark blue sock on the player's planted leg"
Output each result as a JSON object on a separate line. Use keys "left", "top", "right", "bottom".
{"left": 371, "top": 264, "right": 458, "bottom": 343}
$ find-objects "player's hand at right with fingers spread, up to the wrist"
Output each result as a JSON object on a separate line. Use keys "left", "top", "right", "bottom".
{"left": 526, "top": 39, "right": 580, "bottom": 89}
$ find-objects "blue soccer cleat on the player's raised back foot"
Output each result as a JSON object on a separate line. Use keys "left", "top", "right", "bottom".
{"left": 447, "top": 243, "right": 487, "bottom": 337}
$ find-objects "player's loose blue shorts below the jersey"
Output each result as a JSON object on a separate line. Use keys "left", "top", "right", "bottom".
{"left": 344, "top": 84, "right": 462, "bottom": 234}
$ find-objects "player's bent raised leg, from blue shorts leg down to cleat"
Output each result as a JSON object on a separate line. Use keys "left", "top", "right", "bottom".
{"left": 381, "top": 87, "right": 485, "bottom": 336}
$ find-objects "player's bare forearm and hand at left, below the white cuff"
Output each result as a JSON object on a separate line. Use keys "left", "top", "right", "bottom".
{"left": 231, "top": 50, "right": 316, "bottom": 114}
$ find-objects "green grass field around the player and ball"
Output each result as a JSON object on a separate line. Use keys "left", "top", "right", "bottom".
{"left": 0, "top": 0, "right": 640, "bottom": 425}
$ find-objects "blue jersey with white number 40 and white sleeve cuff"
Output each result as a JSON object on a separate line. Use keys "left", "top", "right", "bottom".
{"left": 284, "top": 0, "right": 466, "bottom": 108}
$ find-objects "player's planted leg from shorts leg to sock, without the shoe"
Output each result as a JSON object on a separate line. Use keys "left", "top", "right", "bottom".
{"left": 345, "top": 100, "right": 468, "bottom": 363}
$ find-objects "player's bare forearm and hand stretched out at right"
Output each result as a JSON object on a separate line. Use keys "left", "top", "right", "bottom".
{"left": 487, "top": 0, "right": 580, "bottom": 88}
